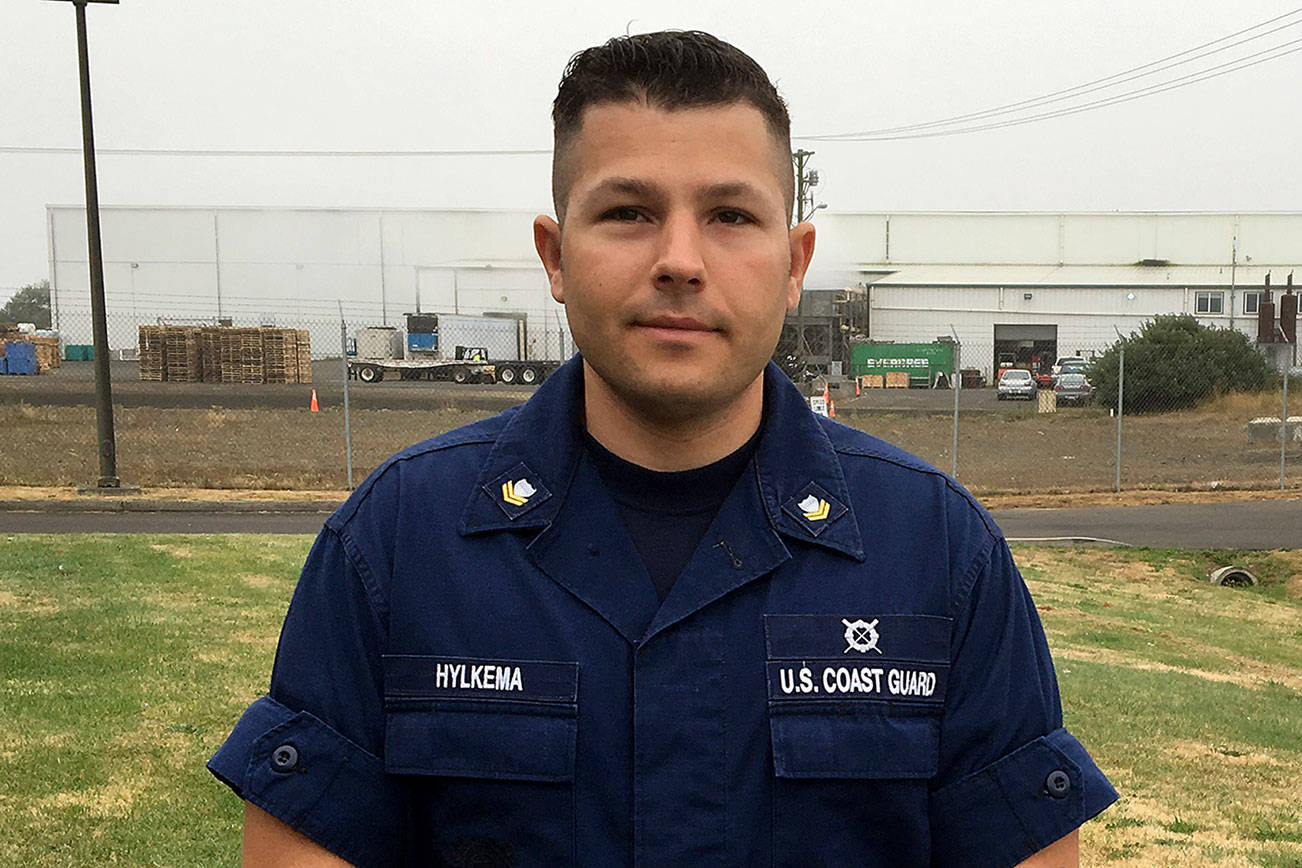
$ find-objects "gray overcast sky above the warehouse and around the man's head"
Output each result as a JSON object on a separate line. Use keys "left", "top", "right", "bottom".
{"left": 0, "top": 0, "right": 1302, "bottom": 299}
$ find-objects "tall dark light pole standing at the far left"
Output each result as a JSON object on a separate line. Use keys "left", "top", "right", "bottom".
{"left": 49, "top": 0, "right": 122, "bottom": 493}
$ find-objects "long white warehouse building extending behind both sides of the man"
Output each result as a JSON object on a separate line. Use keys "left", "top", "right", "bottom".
{"left": 47, "top": 206, "right": 1302, "bottom": 371}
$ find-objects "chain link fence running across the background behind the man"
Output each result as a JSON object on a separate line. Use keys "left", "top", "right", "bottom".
{"left": 0, "top": 305, "right": 1302, "bottom": 495}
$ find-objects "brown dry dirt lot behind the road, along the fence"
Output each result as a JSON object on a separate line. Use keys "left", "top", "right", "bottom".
{"left": 0, "top": 362, "right": 1302, "bottom": 495}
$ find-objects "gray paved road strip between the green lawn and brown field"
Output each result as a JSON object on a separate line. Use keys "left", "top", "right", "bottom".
{"left": 0, "top": 500, "right": 1302, "bottom": 549}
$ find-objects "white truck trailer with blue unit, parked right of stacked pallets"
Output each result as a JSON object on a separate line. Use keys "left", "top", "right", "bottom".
{"left": 348, "top": 308, "right": 561, "bottom": 385}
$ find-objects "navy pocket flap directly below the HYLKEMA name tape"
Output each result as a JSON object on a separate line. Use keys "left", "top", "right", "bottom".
{"left": 384, "top": 708, "right": 578, "bottom": 781}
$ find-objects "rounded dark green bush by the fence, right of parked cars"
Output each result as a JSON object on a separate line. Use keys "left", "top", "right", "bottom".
{"left": 1088, "top": 314, "right": 1276, "bottom": 413}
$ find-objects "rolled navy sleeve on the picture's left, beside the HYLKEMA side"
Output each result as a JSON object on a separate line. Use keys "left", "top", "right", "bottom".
{"left": 208, "top": 526, "right": 408, "bottom": 868}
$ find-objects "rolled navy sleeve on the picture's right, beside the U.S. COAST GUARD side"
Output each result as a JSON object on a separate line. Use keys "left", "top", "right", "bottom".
{"left": 930, "top": 537, "right": 1117, "bottom": 868}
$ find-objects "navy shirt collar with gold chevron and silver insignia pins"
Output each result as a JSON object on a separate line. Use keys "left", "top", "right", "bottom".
{"left": 460, "top": 355, "right": 865, "bottom": 561}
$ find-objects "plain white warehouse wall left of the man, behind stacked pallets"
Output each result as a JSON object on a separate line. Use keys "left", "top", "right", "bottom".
{"left": 48, "top": 207, "right": 556, "bottom": 354}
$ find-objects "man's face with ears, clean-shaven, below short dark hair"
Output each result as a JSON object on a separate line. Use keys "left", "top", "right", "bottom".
{"left": 534, "top": 103, "right": 814, "bottom": 422}
